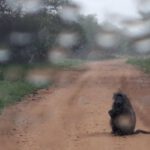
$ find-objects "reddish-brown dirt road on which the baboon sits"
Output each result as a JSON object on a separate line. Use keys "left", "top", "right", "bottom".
{"left": 0, "top": 60, "right": 150, "bottom": 150}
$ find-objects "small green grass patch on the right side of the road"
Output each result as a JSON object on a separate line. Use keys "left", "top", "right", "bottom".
{"left": 127, "top": 58, "right": 150, "bottom": 73}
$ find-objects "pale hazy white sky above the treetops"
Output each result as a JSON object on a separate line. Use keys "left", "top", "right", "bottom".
{"left": 74, "top": 0, "right": 139, "bottom": 21}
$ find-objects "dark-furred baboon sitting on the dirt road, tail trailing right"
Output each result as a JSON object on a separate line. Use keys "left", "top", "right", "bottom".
{"left": 108, "top": 92, "right": 150, "bottom": 136}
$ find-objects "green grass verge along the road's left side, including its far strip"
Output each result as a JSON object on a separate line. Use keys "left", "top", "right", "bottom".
{"left": 0, "top": 59, "right": 83, "bottom": 111}
